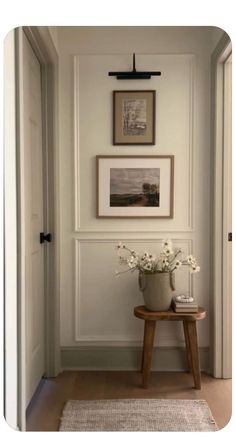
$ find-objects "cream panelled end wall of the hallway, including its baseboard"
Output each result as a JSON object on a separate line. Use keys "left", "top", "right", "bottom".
{"left": 57, "top": 27, "right": 223, "bottom": 370}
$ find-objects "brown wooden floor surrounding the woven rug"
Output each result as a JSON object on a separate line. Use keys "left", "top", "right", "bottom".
{"left": 27, "top": 371, "right": 231, "bottom": 431}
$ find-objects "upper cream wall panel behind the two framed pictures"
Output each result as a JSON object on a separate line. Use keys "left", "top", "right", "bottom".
{"left": 74, "top": 55, "right": 194, "bottom": 232}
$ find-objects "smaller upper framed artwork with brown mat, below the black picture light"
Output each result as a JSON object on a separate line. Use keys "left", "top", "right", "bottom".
{"left": 113, "top": 90, "right": 156, "bottom": 145}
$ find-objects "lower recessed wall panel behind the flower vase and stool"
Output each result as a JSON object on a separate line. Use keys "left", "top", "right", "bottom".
{"left": 74, "top": 239, "right": 196, "bottom": 346}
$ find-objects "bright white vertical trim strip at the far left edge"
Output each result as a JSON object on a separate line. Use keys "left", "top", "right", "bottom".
{"left": 4, "top": 30, "right": 18, "bottom": 429}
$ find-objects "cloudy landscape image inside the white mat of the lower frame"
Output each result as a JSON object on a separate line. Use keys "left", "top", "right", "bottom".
{"left": 110, "top": 168, "right": 160, "bottom": 207}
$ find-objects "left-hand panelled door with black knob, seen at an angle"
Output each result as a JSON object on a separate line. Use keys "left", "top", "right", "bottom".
{"left": 20, "top": 33, "right": 45, "bottom": 406}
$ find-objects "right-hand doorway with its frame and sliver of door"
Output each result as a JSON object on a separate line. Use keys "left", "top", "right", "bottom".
{"left": 212, "top": 36, "right": 232, "bottom": 378}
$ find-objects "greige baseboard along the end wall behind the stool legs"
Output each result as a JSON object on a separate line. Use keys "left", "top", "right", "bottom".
{"left": 61, "top": 346, "right": 209, "bottom": 372}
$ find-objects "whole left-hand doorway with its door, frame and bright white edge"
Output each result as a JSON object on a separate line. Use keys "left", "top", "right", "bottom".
{"left": 4, "top": 27, "right": 60, "bottom": 431}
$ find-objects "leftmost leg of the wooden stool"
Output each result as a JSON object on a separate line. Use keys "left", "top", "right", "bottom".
{"left": 142, "top": 320, "right": 156, "bottom": 388}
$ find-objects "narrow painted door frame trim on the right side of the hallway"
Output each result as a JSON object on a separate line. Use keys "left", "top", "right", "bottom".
{"left": 212, "top": 35, "right": 231, "bottom": 378}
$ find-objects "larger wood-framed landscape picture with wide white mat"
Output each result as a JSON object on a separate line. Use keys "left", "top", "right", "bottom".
{"left": 96, "top": 155, "right": 174, "bottom": 218}
